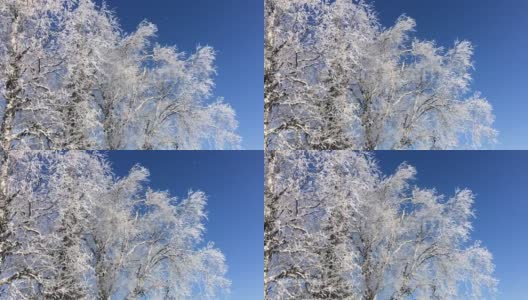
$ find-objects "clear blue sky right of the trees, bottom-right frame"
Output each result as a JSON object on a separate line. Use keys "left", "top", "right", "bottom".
{"left": 376, "top": 151, "right": 528, "bottom": 300}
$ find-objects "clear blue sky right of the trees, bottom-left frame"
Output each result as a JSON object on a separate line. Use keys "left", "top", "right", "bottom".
{"left": 107, "top": 151, "right": 264, "bottom": 300}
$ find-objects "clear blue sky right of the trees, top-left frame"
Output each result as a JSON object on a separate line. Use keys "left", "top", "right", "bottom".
{"left": 96, "top": 0, "right": 264, "bottom": 150}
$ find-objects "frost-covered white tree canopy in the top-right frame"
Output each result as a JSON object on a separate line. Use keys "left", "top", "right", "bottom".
{"left": 264, "top": 0, "right": 497, "bottom": 150}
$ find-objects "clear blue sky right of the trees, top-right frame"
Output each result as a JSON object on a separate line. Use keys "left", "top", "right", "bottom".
{"left": 374, "top": 0, "right": 528, "bottom": 150}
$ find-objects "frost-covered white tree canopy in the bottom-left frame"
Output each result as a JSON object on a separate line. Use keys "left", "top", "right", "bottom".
{"left": 0, "top": 151, "right": 230, "bottom": 300}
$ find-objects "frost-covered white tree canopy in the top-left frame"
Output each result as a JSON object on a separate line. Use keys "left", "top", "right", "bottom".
{"left": 0, "top": 0, "right": 240, "bottom": 150}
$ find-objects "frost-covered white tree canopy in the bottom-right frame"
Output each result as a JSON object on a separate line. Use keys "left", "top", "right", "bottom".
{"left": 264, "top": 151, "right": 497, "bottom": 300}
